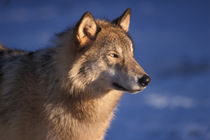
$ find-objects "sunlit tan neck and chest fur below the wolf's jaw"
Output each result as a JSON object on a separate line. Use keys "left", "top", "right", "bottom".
{"left": 45, "top": 91, "right": 122, "bottom": 140}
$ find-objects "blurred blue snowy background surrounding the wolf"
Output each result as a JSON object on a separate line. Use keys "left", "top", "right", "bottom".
{"left": 0, "top": 0, "right": 210, "bottom": 140}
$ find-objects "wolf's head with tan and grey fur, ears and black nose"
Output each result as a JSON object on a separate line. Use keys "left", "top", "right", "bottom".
{"left": 69, "top": 9, "right": 150, "bottom": 93}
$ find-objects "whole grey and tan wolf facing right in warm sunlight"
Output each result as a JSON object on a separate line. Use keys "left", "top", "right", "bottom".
{"left": 0, "top": 9, "right": 150, "bottom": 140}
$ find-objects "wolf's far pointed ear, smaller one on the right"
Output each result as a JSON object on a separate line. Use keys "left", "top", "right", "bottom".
{"left": 112, "top": 8, "right": 131, "bottom": 32}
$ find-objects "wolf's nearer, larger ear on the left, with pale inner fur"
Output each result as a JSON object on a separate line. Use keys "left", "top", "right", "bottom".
{"left": 75, "top": 12, "right": 98, "bottom": 47}
